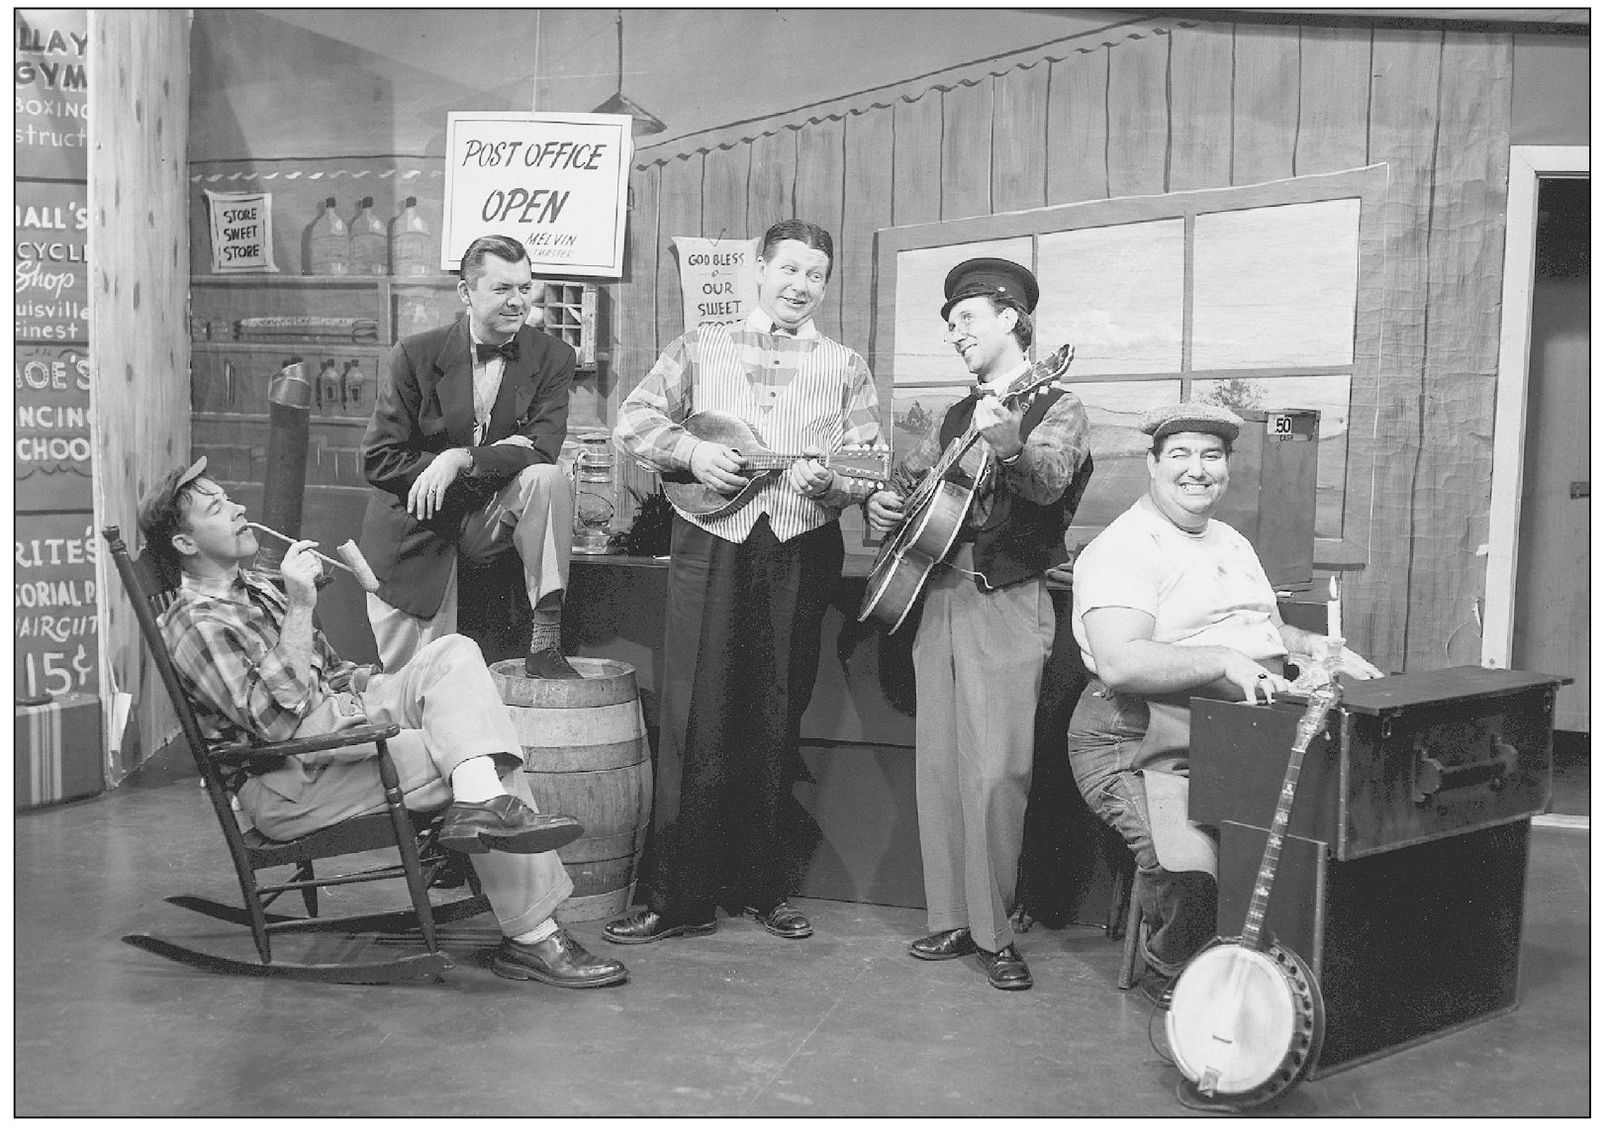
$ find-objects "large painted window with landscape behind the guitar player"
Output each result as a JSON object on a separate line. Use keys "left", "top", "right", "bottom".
{"left": 881, "top": 169, "right": 1380, "bottom": 558}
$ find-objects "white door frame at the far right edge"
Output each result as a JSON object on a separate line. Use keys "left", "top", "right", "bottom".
{"left": 1480, "top": 146, "right": 1591, "bottom": 669}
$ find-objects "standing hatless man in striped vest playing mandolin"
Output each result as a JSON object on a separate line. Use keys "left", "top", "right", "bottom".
{"left": 603, "top": 219, "right": 879, "bottom": 943}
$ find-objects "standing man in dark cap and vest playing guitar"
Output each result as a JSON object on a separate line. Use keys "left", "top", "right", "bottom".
{"left": 866, "top": 257, "right": 1090, "bottom": 990}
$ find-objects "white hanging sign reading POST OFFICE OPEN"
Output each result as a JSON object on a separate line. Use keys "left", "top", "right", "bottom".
{"left": 440, "top": 111, "right": 632, "bottom": 278}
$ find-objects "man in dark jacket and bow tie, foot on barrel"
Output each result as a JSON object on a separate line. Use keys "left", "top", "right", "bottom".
{"left": 362, "top": 235, "right": 580, "bottom": 678}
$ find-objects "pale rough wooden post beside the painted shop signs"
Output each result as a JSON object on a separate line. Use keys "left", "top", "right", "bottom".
{"left": 88, "top": 8, "right": 190, "bottom": 784}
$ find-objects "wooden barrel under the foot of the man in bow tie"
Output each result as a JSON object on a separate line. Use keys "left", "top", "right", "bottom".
{"left": 492, "top": 657, "right": 652, "bottom": 921}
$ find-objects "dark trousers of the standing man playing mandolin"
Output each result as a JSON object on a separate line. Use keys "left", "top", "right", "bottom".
{"left": 648, "top": 516, "right": 842, "bottom": 922}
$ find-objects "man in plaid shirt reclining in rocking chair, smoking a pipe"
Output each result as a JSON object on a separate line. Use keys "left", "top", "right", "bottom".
{"left": 140, "top": 458, "right": 628, "bottom": 987}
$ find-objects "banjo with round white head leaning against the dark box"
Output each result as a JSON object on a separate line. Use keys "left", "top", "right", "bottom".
{"left": 1167, "top": 680, "right": 1339, "bottom": 1107}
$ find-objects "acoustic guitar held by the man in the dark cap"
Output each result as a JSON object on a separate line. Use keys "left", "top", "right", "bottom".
{"left": 860, "top": 344, "right": 1073, "bottom": 630}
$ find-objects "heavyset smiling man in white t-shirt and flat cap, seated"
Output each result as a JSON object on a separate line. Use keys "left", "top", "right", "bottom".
{"left": 1067, "top": 403, "right": 1380, "bottom": 977}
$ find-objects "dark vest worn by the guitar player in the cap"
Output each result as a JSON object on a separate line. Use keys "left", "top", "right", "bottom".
{"left": 938, "top": 386, "right": 1094, "bottom": 590}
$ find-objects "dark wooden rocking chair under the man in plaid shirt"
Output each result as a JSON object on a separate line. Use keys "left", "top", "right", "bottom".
{"left": 101, "top": 527, "right": 490, "bottom": 984}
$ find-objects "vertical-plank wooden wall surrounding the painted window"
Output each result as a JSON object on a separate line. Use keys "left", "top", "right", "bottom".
{"left": 614, "top": 16, "right": 1514, "bottom": 670}
